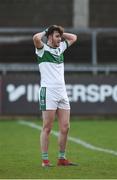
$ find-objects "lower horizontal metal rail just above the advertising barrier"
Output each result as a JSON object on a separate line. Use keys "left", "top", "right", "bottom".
{"left": 0, "top": 63, "right": 117, "bottom": 75}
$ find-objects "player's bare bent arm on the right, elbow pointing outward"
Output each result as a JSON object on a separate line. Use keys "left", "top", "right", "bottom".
{"left": 63, "top": 33, "right": 77, "bottom": 46}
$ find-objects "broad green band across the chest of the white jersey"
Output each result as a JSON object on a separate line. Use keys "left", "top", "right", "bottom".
{"left": 37, "top": 51, "right": 64, "bottom": 64}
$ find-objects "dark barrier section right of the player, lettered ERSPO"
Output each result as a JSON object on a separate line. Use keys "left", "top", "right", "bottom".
{"left": 66, "top": 75, "right": 117, "bottom": 115}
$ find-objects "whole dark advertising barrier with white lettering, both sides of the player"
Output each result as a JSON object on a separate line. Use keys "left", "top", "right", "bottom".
{"left": 3, "top": 74, "right": 117, "bottom": 115}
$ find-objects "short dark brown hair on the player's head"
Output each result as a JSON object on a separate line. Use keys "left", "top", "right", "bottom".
{"left": 46, "top": 25, "right": 64, "bottom": 37}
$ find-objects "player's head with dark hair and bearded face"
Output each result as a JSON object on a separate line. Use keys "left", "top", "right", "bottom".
{"left": 46, "top": 25, "right": 64, "bottom": 47}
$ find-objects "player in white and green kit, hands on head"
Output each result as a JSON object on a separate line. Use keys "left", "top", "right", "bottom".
{"left": 33, "top": 25, "right": 77, "bottom": 167}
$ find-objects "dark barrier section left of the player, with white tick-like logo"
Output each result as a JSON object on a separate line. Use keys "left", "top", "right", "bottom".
{"left": 3, "top": 74, "right": 40, "bottom": 115}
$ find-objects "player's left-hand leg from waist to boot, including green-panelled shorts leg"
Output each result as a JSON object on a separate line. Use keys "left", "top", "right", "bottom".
{"left": 39, "top": 87, "right": 57, "bottom": 166}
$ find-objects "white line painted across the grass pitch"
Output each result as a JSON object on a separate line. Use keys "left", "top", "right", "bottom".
{"left": 18, "top": 120, "right": 117, "bottom": 156}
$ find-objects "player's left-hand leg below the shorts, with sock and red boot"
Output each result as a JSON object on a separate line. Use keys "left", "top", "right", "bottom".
{"left": 40, "top": 110, "right": 56, "bottom": 166}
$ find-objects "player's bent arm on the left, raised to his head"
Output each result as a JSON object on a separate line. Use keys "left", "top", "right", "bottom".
{"left": 33, "top": 31, "right": 46, "bottom": 49}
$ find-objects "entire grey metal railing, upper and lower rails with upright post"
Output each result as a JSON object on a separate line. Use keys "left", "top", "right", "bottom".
{"left": 0, "top": 28, "right": 117, "bottom": 74}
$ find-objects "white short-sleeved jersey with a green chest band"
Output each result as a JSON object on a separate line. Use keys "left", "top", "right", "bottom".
{"left": 36, "top": 41, "right": 68, "bottom": 87}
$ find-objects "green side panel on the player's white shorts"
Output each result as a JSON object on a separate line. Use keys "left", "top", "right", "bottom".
{"left": 39, "top": 87, "right": 46, "bottom": 111}
